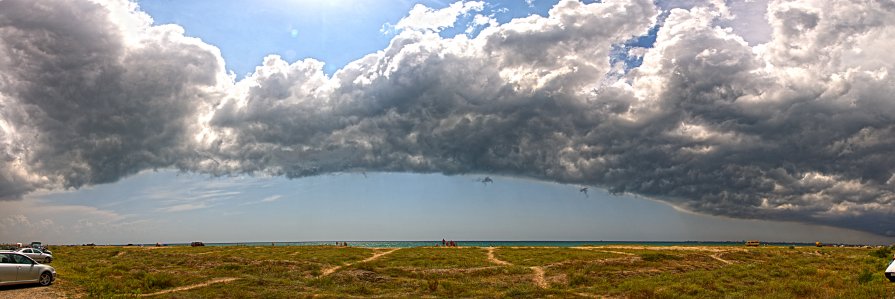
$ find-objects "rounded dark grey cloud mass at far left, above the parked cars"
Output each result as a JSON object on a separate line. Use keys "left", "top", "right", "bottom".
{"left": 0, "top": 1, "right": 222, "bottom": 197}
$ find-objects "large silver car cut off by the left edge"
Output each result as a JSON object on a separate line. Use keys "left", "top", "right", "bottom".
{"left": 0, "top": 252, "right": 56, "bottom": 286}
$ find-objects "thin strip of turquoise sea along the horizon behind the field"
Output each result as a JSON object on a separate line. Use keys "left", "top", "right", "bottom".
{"left": 149, "top": 240, "right": 814, "bottom": 248}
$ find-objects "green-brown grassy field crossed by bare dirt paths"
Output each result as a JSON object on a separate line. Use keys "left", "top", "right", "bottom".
{"left": 24, "top": 246, "right": 895, "bottom": 298}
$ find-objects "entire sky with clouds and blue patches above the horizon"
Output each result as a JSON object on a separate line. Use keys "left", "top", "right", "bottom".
{"left": 0, "top": 0, "right": 895, "bottom": 244}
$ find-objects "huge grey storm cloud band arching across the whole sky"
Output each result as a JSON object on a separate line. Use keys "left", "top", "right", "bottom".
{"left": 0, "top": 0, "right": 895, "bottom": 235}
